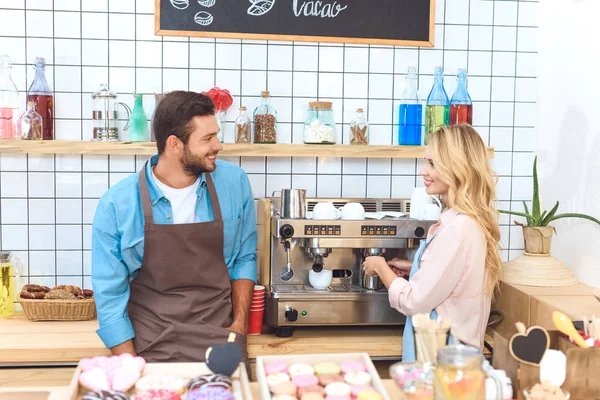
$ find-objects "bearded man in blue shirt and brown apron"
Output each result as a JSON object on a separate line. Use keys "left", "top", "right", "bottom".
{"left": 92, "top": 91, "right": 257, "bottom": 362}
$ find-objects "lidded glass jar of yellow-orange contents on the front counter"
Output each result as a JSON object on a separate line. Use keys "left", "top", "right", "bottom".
{"left": 433, "top": 345, "right": 503, "bottom": 400}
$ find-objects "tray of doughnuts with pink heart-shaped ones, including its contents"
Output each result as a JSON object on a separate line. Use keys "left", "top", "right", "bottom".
{"left": 69, "top": 354, "right": 252, "bottom": 400}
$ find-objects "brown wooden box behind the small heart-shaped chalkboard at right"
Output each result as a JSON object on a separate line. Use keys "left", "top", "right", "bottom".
{"left": 493, "top": 330, "right": 600, "bottom": 400}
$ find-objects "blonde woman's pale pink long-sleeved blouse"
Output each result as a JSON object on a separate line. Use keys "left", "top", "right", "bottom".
{"left": 389, "top": 209, "right": 491, "bottom": 349}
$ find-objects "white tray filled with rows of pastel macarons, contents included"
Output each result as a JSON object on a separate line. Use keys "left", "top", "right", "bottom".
{"left": 256, "top": 353, "right": 390, "bottom": 400}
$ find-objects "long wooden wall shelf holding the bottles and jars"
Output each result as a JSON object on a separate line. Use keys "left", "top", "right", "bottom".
{"left": 0, "top": 140, "right": 494, "bottom": 158}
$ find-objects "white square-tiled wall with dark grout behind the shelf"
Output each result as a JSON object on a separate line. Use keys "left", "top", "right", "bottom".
{"left": 0, "top": 0, "right": 539, "bottom": 286}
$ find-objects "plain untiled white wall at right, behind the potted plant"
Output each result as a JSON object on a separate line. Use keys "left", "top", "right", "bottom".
{"left": 537, "top": 0, "right": 600, "bottom": 287}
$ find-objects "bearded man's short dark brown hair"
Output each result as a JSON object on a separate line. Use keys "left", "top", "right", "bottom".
{"left": 152, "top": 90, "right": 215, "bottom": 154}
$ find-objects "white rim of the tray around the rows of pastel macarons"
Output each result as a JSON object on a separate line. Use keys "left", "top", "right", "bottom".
{"left": 256, "top": 353, "right": 390, "bottom": 400}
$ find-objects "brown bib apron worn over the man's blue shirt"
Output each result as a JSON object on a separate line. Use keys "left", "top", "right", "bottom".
{"left": 128, "top": 167, "right": 247, "bottom": 362}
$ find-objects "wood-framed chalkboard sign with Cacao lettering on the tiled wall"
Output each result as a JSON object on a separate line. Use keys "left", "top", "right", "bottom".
{"left": 155, "top": 0, "right": 435, "bottom": 47}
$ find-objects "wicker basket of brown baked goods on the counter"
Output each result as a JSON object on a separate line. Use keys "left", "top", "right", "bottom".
{"left": 19, "top": 285, "right": 96, "bottom": 321}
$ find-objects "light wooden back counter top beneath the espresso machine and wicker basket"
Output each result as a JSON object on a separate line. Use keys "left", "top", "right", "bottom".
{"left": 0, "top": 313, "right": 402, "bottom": 366}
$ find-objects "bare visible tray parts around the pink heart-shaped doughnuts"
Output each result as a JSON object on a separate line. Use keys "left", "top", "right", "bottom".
{"left": 65, "top": 363, "right": 253, "bottom": 400}
